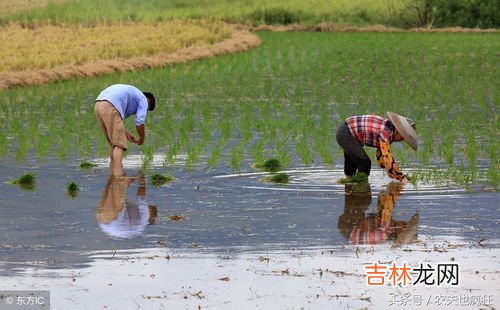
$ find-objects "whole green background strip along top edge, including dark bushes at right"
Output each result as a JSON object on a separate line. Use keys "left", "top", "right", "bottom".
{"left": 0, "top": 0, "right": 500, "bottom": 28}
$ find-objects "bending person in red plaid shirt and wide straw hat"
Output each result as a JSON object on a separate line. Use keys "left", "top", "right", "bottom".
{"left": 337, "top": 112, "right": 417, "bottom": 184}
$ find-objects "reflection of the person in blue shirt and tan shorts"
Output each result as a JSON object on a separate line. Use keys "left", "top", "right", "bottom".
{"left": 96, "top": 176, "right": 157, "bottom": 238}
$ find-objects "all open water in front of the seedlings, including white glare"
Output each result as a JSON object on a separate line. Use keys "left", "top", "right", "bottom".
{"left": 0, "top": 155, "right": 500, "bottom": 309}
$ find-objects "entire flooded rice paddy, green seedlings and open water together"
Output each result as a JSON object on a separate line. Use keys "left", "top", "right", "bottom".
{"left": 0, "top": 33, "right": 500, "bottom": 309}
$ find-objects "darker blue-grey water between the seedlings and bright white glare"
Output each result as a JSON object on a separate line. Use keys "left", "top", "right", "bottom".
{"left": 0, "top": 156, "right": 500, "bottom": 275}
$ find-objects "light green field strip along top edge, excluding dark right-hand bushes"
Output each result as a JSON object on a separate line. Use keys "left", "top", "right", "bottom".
{"left": 0, "top": 0, "right": 409, "bottom": 26}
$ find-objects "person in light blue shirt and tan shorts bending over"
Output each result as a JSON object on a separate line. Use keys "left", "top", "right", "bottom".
{"left": 95, "top": 84, "right": 155, "bottom": 176}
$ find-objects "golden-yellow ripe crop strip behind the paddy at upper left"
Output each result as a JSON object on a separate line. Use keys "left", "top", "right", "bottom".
{"left": 0, "top": 21, "right": 229, "bottom": 72}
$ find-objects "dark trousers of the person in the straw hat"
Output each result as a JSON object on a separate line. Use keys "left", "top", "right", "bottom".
{"left": 337, "top": 122, "right": 372, "bottom": 176}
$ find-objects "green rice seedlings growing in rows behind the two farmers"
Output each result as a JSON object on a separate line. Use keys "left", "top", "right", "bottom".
{"left": 0, "top": 32, "right": 500, "bottom": 186}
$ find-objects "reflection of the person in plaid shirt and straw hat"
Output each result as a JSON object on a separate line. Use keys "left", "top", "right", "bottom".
{"left": 337, "top": 182, "right": 419, "bottom": 248}
